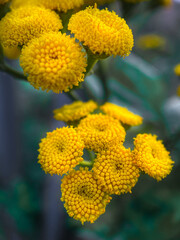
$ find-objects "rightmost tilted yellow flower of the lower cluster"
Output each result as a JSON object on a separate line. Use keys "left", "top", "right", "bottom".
{"left": 133, "top": 134, "right": 173, "bottom": 181}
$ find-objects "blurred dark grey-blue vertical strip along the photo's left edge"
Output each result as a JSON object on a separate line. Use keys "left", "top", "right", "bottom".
{"left": 0, "top": 72, "right": 19, "bottom": 186}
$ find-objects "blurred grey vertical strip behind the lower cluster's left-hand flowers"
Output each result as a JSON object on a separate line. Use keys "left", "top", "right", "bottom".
{"left": 42, "top": 94, "right": 71, "bottom": 240}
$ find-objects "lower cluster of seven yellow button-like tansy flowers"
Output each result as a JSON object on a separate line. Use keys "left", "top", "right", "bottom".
{"left": 38, "top": 101, "right": 173, "bottom": 224}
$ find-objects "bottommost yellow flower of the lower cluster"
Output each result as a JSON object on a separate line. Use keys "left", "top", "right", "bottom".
{"left": 61, "top": 168, "right": 111, "bottom": 224}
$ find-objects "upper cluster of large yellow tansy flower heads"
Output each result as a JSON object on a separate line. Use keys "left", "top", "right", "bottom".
{"left": 0, "top": 4, "right": 134, "bottom": 93}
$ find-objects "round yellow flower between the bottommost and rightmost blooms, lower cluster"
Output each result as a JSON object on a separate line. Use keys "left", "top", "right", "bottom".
{"left": 92, "top": 145, "right": 139, "bottom": 194}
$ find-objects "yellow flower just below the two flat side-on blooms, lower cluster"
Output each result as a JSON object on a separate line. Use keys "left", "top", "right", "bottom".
{"left": 77, "top": 114, "right": 126, "bottom": 152}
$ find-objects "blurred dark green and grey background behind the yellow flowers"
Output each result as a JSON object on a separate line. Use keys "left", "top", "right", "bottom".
{"left": 0, "top": 0, "right": 180, "bottom": 240}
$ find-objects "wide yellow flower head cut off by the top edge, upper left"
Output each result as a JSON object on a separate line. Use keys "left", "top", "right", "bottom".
{"left": 12, "top": 0, "right": 84, "bottom": 12}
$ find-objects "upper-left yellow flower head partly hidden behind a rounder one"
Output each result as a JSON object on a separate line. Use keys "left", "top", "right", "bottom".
{"left": 0, "top": 6, "right": 63, "bottom": 47}
